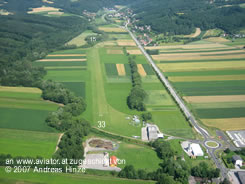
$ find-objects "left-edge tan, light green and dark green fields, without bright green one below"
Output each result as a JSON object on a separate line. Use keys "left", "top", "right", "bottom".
{"left": 0, "top": 86, "right": 59, "bottom": 132}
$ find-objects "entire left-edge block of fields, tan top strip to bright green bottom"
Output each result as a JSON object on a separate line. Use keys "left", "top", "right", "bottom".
{"left": 0, "top": 86, "right": 59, "bottom": 158}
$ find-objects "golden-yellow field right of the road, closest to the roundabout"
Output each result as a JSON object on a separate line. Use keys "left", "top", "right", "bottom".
{"left": 201, "top": 118, "right": 245, "bottom": 130}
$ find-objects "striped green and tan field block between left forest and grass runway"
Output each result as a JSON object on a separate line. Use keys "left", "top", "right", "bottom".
{"left": 34, "top": 49, "right": 89, "bottom": 97}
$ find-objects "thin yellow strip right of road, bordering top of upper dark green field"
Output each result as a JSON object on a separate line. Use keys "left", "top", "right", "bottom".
{"left": 168, "top": 75, "right": 245, "bottom": 82}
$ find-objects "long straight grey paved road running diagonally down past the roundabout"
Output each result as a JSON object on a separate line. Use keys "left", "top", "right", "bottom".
{"left": 125, "top": 24, "right": 228, "bottom": 178}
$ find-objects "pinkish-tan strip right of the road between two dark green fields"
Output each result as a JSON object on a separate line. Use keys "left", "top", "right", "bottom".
{"left": 183, "top": 95, "right": 245, "bottom": 103}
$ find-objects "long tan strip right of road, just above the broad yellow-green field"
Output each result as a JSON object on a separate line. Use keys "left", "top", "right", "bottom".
{"left": 152, "top": 51, "right": 245, "bottom": 61}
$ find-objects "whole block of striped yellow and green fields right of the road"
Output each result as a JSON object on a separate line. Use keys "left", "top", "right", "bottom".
{"left": 148, "top": 38, "right": 245, "bottom": 130}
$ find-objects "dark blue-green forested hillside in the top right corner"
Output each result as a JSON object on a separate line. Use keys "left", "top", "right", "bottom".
{"left": 129, "top": 0, "right": 245, "bottom": 35}
